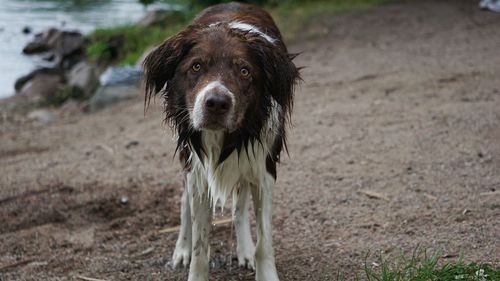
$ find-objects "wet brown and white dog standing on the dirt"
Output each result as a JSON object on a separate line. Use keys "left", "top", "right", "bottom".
{"left": 144, "top": 3, "right": 299, "bottom": 281}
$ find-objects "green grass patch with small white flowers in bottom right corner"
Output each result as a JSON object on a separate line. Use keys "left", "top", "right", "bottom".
{"left": 344, "top": 248, "right": 500, "bottom": 281}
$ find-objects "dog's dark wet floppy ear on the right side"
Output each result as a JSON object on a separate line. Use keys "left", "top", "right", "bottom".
{"left": 246, "top": 34, "right": 300, "bottom": 116}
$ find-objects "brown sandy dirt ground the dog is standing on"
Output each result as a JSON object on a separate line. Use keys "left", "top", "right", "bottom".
{"left": 0, "top": 1, "right": 500, "bottom": 281}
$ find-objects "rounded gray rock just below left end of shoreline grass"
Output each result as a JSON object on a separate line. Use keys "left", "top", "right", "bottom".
{"left": 68, "top": 61, "right": 99, "bottom": 97}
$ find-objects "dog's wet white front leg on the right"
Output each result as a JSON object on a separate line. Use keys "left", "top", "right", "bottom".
{"left": 252, "top": 173, "right": 279, "bottom": 281}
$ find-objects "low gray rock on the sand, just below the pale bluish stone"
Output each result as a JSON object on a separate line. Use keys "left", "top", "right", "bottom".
{"left": 89, "top": 85, "right": 140, "bottom": 112}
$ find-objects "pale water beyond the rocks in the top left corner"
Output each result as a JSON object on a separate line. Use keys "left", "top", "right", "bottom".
{"left": 0, "top": 0, "right": 179, "bottom": 98}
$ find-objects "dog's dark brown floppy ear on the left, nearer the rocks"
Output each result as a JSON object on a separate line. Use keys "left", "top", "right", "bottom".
{"left": 143, "top": 27, "right": 194, "bottom": 107}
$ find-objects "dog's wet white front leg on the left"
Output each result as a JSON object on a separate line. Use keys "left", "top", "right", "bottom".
{"left": 188, "top": 175, "right": 212, "bottom": 281}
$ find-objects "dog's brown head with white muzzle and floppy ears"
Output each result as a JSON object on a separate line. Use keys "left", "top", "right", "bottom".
{"left": 144, "top": 23, "right": 298, "bottom": 149}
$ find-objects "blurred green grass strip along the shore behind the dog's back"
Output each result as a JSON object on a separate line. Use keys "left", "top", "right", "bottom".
{"left": 87, "top": 0, "right": 388, "bottom": 64}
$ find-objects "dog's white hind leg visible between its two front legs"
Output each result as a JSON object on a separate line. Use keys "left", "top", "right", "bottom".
{"left": 233, "top": 183, "right": 255, "bottom": 269}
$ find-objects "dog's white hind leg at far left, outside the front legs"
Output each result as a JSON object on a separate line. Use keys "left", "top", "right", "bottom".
{"left": 172, "top": 180, "right": 191, "bottom": 268}
